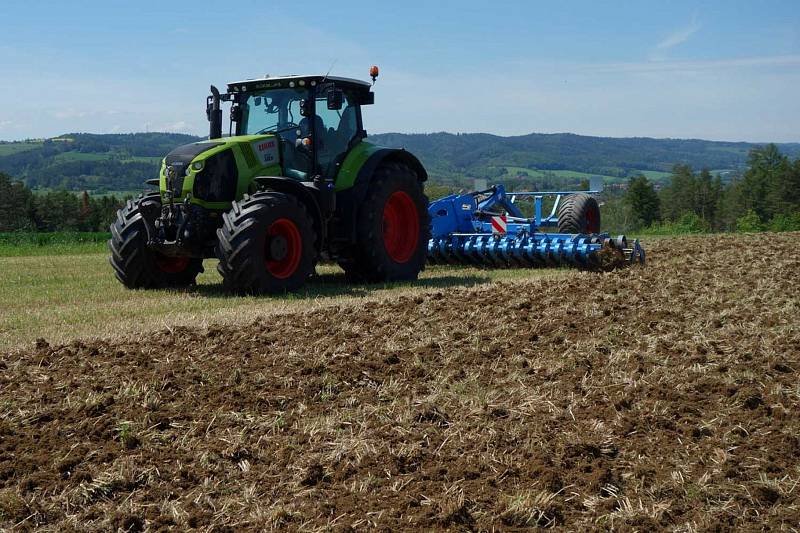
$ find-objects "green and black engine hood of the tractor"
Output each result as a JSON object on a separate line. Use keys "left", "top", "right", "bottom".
{"left": 159, "top": 134, "right": 281, "bottom": 209}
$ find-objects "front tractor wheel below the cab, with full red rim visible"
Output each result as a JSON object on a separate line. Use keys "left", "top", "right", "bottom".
{"left": 217, "top": 191, "right": 316, "bottom": 294}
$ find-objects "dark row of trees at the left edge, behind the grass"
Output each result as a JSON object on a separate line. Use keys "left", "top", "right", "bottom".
{"left": 0, "top": 172, "right": 126, "bottom": 232}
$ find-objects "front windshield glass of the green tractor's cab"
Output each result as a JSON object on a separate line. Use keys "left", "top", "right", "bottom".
{"left": 239, "top": 88, "right": 308, "bottom": 139}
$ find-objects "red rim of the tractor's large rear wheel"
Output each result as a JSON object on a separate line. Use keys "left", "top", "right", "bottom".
{"left": 383, "top": 191, "right": 419, "bottom": 263}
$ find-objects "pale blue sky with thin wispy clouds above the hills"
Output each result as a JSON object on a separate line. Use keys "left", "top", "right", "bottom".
{"left": 0, "top": 0, "right": 800, "bottom": 142}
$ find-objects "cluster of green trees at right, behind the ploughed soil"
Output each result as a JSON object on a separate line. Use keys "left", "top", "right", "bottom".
{"left": 616, "top": 144, "right": 800, "bottom": 233}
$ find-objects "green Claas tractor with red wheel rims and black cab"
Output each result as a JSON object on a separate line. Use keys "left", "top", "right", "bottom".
{"left": 109, "top": 67, "right": 430, "bottom": 294}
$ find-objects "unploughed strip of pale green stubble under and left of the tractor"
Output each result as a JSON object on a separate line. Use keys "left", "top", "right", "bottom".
{"left": 0, "top": 249, "right": 574, "bottom": 349}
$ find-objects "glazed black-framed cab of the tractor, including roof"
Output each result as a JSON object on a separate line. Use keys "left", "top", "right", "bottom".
{"left": 208, "top": 76, "right": 374, "bottom": 181}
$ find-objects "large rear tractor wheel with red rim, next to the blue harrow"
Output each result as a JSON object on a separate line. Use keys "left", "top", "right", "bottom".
{"left": 339, "top": 162, "right": 430, "bottom": 282}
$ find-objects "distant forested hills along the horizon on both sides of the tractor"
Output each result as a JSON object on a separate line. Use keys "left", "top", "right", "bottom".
{"left": 0, "top": 133, "right": 800, "bottom": 192}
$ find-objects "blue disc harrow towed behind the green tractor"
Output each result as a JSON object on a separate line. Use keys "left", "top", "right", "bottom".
{"left": 428, "top": 185, "right": 645, "bottom": 270}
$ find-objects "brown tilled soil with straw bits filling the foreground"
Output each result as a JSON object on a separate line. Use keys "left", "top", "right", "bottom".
{"left": 0, "top": 233, "right": 800, "bottom": 531}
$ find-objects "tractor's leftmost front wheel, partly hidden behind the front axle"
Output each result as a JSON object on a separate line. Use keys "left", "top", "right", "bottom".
{"left": 108, "top": 192, "right": 203, "bottom": 289}
